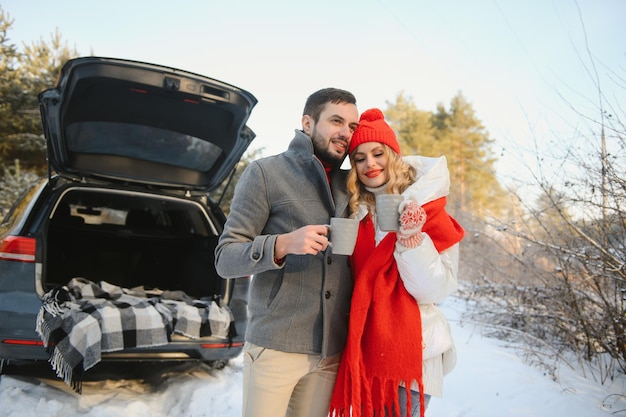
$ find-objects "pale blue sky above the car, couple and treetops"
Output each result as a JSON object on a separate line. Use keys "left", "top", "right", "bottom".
{"left": 2, "top": 0, "right": 626, "bottom": 182}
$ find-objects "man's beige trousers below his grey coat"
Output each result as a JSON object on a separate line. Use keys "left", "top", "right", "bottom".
{"left": 243, "top": 342, "right": 340, "bottom": 417}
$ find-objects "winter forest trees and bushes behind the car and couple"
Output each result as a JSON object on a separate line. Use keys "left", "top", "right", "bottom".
{"left": 0, "top": 2, "right": 626, "bottom": 394}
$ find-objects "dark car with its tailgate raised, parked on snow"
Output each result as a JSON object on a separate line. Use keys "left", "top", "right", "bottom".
{"left": 0, "top": 57, "right": 257, "bottom": 376}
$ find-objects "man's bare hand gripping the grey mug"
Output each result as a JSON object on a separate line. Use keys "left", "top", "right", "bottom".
{"left": 274, "top": 224, "right": 328, "bottom": 259}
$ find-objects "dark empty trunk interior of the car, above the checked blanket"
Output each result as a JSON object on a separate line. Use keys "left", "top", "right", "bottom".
{"left": 43, "top": 188, "right": 226, "bottom": 299}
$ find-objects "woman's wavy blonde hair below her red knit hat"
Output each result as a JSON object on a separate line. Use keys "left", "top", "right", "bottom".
{"left": 347, "top": 143, "right": 417, "bottom": 217}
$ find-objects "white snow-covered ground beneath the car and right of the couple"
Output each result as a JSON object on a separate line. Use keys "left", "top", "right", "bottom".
{"left": 0, "top": 299, "right": 626, "bottom": 417}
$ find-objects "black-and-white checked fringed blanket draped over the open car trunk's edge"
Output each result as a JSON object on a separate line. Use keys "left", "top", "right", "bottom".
{"left": 36, "top": 278, "right": 236, "bottom": 393}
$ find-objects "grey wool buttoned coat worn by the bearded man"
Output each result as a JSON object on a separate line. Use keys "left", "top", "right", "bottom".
{"left": 215, "top": 130, "right": 352, "bottom": 357}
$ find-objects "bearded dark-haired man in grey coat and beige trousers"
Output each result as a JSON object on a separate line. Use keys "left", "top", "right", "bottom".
{"left": 216, "top": 88, "right": 359, "bottom": 417}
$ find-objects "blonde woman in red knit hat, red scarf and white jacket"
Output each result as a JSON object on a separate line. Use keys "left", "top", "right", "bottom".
{"left": 330, "top": 109, "right": 464, "bottom": 417}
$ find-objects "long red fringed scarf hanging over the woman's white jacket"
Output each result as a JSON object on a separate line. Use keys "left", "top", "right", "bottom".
{"left": 330, "top": 197, "right": 463, "bottom": 417}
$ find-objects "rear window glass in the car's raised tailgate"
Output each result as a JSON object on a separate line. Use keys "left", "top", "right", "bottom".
{"left": 66, "top": 121, "right": 222, "bottom": 172}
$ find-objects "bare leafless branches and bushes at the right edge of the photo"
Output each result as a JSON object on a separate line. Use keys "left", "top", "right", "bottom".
{"left": 458, "top": 11, "right": 626, "bottom": 382}
